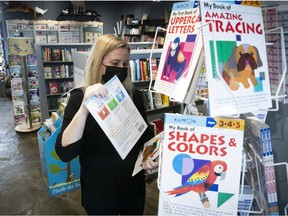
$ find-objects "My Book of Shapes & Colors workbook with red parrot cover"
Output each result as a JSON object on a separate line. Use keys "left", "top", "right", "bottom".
{"left": 158, "top": 113, "right": 245, "bottom": 215}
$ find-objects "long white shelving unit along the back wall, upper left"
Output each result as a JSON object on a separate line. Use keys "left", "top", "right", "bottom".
{"left": 6, "top": 19, "right": 103, "bottom": 44}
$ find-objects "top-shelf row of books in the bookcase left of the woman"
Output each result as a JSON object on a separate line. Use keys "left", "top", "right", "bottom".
{"left": 43, "top": 47, "right": 89, "bottom": 62}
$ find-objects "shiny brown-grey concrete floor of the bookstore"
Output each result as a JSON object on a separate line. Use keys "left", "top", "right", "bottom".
{"left": 0, "top": 98, "right": 158, "bottom": 215}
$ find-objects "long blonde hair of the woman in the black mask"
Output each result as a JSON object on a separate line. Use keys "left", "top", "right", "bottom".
{"left": 83, "top": 34, "right": 133, "bottom": 96}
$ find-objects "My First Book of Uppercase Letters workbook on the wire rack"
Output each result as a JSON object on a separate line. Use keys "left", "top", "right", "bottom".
{"left": 154, "top": 1, "right": 203, "bottom": 102}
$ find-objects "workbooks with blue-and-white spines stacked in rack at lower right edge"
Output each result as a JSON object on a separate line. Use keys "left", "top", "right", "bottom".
{"left": 240, "top": 113, "right": 279, "bottom": 215}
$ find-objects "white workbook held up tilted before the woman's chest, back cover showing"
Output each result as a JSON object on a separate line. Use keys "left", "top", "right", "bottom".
{"left": 85, "top": 75, "right": 148, "bottom": 159}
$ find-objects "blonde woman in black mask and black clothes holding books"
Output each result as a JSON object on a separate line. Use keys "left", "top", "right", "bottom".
{"left": 56, "top": 35, "right": 158, "bottom": 215}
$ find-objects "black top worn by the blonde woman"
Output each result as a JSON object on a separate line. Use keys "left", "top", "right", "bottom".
{"left": 55, "top": 88, "right": 153, "bottom": 199}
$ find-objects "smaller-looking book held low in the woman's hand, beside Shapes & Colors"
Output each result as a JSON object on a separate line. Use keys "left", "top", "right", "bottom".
{"left": 132, "top": 132, "right": 163, "bottom": 176}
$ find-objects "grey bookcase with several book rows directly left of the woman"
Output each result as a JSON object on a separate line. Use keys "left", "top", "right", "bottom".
{"left": 36, "top": 43, "right": 93, "bottom": 121}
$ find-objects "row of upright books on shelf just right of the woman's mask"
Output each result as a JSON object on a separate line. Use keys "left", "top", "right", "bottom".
{"left": 129, "top": 58, "right": 159, "bottom": 82}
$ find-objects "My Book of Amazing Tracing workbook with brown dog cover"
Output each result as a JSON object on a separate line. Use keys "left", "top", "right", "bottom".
{"left": 200, "top": 1, "right": 272, "bottom": 117}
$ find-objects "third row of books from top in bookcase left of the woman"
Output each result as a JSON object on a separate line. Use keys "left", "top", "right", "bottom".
{"left": 46, "top": 80, "right": 74, "bottom": 95}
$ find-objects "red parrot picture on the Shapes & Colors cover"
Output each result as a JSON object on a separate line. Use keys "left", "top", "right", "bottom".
{"left": 167, "top": 160, "right": 227, "bottom": 207}
